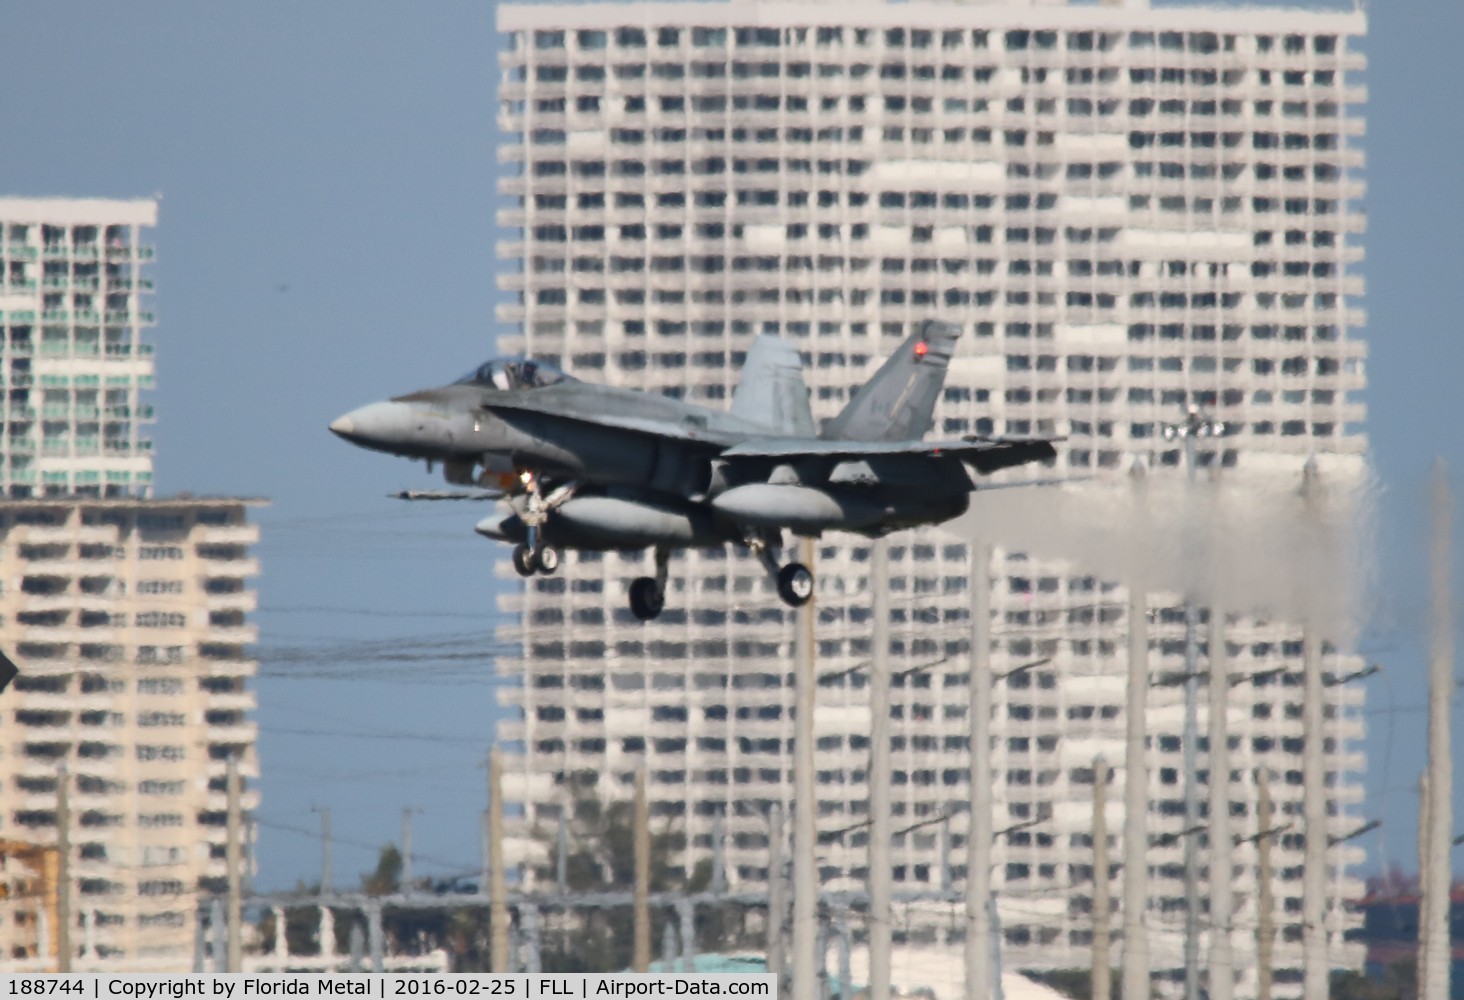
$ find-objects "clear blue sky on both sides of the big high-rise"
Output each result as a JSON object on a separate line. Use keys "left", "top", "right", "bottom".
{"left": 0, "top": 0, "right": 1464, "bottom": 889}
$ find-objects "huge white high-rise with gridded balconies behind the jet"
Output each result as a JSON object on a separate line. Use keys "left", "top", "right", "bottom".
{"left": 499, "top": 3, "right": 1366, "bottom": 996}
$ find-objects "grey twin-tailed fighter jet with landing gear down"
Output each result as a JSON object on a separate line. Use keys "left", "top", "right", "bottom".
{"left": 331, "top": 322, "right": 1054, "bottom": 619}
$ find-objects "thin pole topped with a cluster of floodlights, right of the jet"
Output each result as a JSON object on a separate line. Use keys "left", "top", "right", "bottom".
{"left": 1164, "top": 406, "right": 1230, "bottom": 1000}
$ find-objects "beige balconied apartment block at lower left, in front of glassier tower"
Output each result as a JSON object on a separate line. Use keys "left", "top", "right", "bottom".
{"left": 0, "top": 498, "right": 259, "bottom": 972}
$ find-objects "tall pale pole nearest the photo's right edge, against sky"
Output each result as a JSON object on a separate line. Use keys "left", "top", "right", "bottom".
{"left": 1419, "top": 460, "right": 1454, "bottom": 1000}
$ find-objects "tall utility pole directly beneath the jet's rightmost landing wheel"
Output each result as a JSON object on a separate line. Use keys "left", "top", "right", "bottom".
{"left": 793, "top": 539, "right": 818, "bottom": 997}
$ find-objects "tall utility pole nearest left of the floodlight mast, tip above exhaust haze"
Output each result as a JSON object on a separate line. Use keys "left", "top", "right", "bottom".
{"left": 1121, "top": 464, "right": 1149, "bottom": 1000}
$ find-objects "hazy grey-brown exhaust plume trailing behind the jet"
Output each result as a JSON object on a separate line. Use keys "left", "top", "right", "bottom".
{"left": 944, "top": 460, "right": 1375, "bottom": 646}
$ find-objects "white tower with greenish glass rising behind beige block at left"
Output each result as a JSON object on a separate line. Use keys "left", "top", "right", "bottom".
{"left": 0, "top": 198, "right": 158, "bottom": 498}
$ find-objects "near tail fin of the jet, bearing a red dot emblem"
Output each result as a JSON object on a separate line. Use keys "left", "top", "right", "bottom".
{"left": 820, "top": 319, "right": 960, "bottom": 441}
